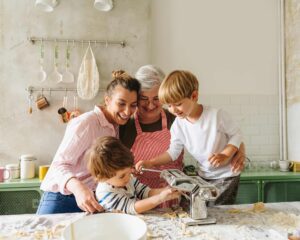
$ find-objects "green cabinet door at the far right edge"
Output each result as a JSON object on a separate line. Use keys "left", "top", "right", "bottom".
{"left": 262, "top": 179, "right": 300, "bottom": 202}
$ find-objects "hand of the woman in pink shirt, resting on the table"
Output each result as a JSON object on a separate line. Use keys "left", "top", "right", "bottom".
{"left": 66, "top": 178, "right": 103, "bottom": 213}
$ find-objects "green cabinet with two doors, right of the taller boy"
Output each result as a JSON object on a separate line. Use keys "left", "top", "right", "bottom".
{"left": 236, "top": 171, "right": 300, "bottom": 204}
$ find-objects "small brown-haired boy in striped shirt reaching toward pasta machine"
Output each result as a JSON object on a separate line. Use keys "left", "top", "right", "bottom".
{"left": 88, "top": 136, "right": 180, "bottom": 214}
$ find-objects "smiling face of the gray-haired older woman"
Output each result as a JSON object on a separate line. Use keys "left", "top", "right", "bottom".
{"left": 138, "top": 85, "right": 162, "bottom": 123}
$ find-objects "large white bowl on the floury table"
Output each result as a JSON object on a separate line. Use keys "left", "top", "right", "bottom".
{"left": 63, "top": 213, "right": 147, "bottom": 240}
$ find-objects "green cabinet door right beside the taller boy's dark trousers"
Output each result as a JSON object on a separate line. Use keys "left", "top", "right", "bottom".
{"left": 235, "top": 180, "right": 261, "bottom": 204}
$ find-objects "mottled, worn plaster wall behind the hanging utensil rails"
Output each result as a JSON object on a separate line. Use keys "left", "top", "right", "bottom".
{"left": 0, "top": 0, "right": 150, "bottom": 166}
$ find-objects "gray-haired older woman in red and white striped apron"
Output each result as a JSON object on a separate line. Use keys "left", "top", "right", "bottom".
{"left": 119, "top": 65, "right": 245, "bottom": 207}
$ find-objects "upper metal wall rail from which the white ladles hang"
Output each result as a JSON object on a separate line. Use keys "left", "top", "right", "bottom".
{"left": 28, "top": 37, "right": 126, "bottom": 47}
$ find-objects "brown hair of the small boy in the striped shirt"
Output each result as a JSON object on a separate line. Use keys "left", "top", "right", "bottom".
{"left": 87, "top": 136, "right": 134, "bottom": 181}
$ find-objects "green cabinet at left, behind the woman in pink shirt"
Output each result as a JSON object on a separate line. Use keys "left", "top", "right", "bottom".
{"left": 0, "top": 178, "right": 42, "bottom": 215}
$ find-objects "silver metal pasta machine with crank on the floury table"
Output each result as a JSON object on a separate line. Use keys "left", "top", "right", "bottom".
{"left": 142, "top": 169, "right": 219, "bottom": 225}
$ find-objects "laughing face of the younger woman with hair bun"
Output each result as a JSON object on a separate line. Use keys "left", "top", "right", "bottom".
{"left": 105, "top": 85, "right": 137, "bottom": 125}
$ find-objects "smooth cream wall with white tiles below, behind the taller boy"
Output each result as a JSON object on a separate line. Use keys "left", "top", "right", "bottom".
{"left": 151, "top": 0, "right": 279, "bottom": 160}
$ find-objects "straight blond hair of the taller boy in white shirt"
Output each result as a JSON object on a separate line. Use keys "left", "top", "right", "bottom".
{"left": 158, "top": 70, "right": 199, "bottom": 104}
